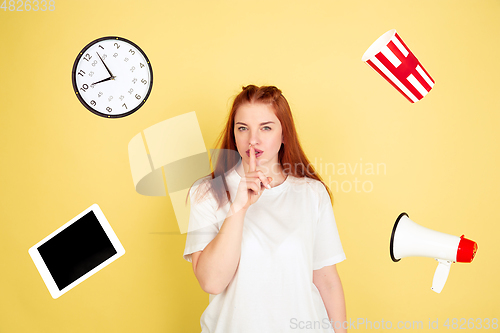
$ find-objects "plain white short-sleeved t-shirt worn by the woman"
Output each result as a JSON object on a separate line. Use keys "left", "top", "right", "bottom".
{"left": 184, "top": 162, "right": 345, "bottom": 333}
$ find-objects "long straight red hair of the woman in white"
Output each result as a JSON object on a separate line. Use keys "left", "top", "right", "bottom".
{"left": 186, "top": 85, "right": 332, "bottom": 209}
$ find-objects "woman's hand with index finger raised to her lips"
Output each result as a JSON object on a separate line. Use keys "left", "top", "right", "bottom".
{"left": 233, "top": 145, "right": 273, "bottom": 210}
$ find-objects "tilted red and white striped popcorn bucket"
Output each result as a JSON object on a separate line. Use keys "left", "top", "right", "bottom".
{"left": 361, "top": 29, "right": 434, "bottom": 103}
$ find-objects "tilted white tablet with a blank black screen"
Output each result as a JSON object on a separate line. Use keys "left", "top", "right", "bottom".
{"left": 28, "top": 204, "right": 125, "bottom": 298}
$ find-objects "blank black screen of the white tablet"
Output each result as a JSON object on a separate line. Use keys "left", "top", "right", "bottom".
{"left": 38, "top": 211, "right": 117, "bottom": 290}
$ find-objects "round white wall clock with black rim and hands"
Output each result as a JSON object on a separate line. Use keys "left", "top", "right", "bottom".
{"left": 73, "top": 37, "right": 153, "bottom": 118}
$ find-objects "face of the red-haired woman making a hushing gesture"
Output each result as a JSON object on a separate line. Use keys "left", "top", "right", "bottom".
{"left": 234, "top": 103, "right": 283, "bottom": 174}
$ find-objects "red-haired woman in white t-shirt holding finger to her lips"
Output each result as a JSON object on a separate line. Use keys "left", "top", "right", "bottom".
{"left": 184, "top": 85, "right": 346, "bottom": 333}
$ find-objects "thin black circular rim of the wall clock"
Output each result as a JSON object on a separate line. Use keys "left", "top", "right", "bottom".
{"left": 71, "top": 36, "right": 153, "bottom": 118}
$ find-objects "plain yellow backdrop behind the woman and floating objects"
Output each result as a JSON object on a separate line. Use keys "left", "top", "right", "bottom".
{"left": 0, "top": 0, "right": 500, "bottom": 333}
